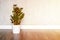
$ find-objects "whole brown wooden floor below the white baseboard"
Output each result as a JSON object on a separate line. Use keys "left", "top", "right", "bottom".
{"left": 0, "top": 29, "right": 60, "bottom": 40}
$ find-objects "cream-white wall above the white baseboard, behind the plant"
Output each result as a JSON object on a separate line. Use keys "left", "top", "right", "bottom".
{"left": 0, "top": 0, "right": 60, "bottom": 24}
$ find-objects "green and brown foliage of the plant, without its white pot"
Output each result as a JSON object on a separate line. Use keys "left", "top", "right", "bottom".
{"left": 11, "top": 4, "right": 24, "bottom": 25}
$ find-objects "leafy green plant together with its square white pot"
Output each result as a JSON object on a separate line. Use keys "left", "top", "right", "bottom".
{"left": 10, "top": 4, "right": 24, "bottom": 33}
